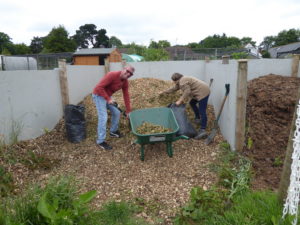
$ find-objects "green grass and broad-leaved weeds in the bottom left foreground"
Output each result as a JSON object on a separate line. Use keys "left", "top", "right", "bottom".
{"left": 0, "top": 177, "right": 150, "bottom": 225}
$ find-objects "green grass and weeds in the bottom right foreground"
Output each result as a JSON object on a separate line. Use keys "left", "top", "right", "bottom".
{"left": 174, "top": 143, "right": 293, "bottom": 225}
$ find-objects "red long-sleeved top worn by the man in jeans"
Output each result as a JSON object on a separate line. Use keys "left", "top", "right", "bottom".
{"left": 93, "top": 71, "right": 131, "bottom": 113}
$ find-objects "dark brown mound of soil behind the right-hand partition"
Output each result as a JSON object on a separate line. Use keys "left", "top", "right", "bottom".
{"left": 243, "top": 74, "right": 300, "bottom": 190}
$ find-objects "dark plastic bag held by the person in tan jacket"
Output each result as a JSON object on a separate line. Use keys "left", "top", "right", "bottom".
{"left": 168, "top": 104, "right": 197, "bottom": 138}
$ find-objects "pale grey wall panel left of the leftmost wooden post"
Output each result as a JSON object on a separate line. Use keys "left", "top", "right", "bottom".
{"left": 0, "top": 70, "right": 62, "bottom": 142}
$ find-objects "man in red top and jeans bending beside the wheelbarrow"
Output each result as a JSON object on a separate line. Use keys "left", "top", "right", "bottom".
{"left": 92, "top": 66, "right": 134, "bottom": 150}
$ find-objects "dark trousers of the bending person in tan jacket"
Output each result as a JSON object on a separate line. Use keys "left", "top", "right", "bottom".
{"left": 190, "top": 95, "right": 209, "bottom": 129}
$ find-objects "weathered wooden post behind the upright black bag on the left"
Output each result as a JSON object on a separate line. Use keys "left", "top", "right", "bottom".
{"left": 58, "top": 59, "right": 69, "bottom": 108}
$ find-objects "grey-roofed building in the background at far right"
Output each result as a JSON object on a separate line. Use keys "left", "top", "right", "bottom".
{"left": 269, "top": 42, "right": 300, "bottom": 58}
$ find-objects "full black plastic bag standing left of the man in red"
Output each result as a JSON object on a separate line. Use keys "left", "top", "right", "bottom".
{"left": 64, "top": 105, "right": 86, "bottom": 143}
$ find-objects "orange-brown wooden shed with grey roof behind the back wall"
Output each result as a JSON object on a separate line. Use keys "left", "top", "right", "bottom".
{"left": 73, "top": 48, "right": 122, "bottom": 65}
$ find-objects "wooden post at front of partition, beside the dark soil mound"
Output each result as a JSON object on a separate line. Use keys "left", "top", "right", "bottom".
{"left": 235, "top": 59, "right": 248, "bottom": 151}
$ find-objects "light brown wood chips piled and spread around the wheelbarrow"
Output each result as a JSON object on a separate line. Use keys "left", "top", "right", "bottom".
{"left": 0, "top": 78, "right": 223, "bottom": 224}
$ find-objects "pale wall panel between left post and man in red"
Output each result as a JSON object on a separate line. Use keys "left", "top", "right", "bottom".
{"left": 67, "top": 66, "right": 105, "bottom": 105}
